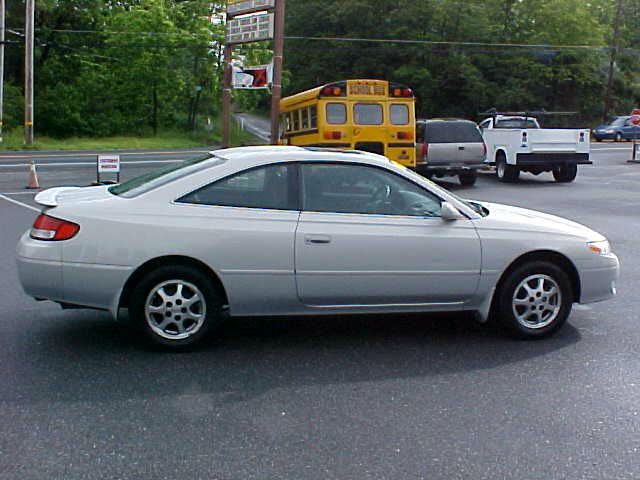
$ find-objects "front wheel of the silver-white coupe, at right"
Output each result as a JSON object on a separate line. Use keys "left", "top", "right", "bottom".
{"left": 492, "top": 261, "right": 573, "bottom": 339}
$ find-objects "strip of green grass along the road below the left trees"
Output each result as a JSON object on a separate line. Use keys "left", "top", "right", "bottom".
{"left": 0, "top": 122, "right": 260, "bottom": 151}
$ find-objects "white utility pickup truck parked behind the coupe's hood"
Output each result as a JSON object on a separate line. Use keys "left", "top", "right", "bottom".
{"left": 479, "top": 115, "right": 592, "bottom": 182}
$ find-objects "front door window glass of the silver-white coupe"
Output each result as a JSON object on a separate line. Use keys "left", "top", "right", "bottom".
{"left": 301, "top": 163, "right": 441, "bottom": 217}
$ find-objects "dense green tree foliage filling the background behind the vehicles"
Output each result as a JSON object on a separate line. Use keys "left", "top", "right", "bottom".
{"left": 5, "top": 0, "right": 640, "bottom": 137}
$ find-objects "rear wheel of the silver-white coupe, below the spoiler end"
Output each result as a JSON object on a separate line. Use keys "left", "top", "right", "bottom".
{"left": 130, "top": 265, "right": 223, "bottom": 350}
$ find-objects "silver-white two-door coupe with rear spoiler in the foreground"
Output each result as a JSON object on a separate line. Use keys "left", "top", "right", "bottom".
{"left": 17, "top": 147, "right": 619, "bottom": 348}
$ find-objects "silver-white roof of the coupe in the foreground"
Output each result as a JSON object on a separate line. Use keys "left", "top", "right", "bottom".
{"left": 209, "top": 145, "right": 390, "bottom": 165}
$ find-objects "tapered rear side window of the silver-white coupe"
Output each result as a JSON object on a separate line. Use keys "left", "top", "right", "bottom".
{"left": 176, "top": 164, "right": 297, "bottom": 210}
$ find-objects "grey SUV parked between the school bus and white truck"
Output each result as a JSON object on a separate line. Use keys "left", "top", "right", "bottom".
{"left": 416, "top": 119, "right": 487, "bottom": 186}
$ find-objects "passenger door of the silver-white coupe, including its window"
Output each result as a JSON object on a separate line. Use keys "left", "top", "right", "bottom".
{"left": 295, "top": 163, "right": 481, "bottom": 306}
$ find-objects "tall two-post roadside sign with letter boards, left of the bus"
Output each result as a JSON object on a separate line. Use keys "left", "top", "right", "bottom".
{"left": 222, "top": 0, "right": 285, "bottom": 147}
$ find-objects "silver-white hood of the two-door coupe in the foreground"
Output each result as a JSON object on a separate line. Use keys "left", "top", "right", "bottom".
{"left": 478, "top": 202, "right": 606, "bottom": 242}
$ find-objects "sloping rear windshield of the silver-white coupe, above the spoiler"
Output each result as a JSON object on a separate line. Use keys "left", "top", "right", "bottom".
{"left": 109, "top": 153, "right": 224, "bottom": 198}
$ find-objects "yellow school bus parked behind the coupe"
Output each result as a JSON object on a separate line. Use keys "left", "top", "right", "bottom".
{"left": 280, "top": 80, "right": 416, "bottom": 167}
